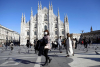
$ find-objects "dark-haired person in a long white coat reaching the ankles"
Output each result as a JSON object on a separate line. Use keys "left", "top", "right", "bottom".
{"left": 66, "top": 33, "right": 74, "bottom": 57}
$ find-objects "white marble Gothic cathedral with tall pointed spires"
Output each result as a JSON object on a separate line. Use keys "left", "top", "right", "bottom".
{"left": 20, "top": 2, "right": 69, "bottom": 45}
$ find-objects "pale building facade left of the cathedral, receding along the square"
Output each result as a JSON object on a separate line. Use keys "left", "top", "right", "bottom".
{"left": 0, "top": 25, "right": 20, "bottom": 45}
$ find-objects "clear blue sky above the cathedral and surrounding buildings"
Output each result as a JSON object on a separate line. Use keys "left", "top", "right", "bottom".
{"left": 0, "top": 0, "right": 100, "bottom": 33}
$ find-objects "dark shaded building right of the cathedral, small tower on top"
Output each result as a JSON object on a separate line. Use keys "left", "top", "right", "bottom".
{"left": 70, "top": 27, "right": 100, "bottom": 43}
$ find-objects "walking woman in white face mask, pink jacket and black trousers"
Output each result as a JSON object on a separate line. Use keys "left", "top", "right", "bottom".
{"left": 43, "top": 30, "right": 52, "bottom": 66}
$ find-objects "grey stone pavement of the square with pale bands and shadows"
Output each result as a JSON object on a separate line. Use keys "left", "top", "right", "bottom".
{"left": 0, "top": 44, "right": 100, "bottom": 67}
